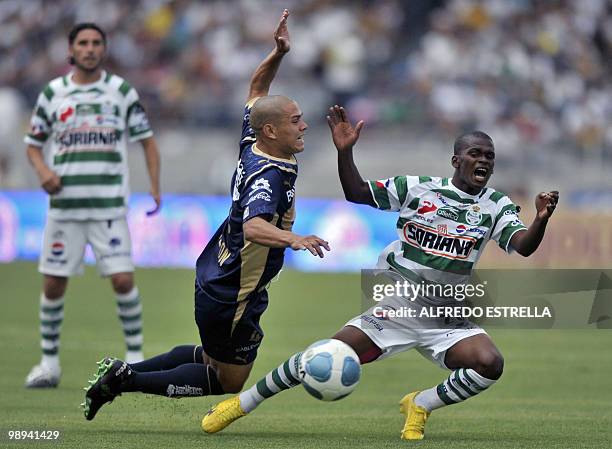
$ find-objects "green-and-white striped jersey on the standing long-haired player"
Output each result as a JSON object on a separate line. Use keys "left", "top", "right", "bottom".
{"left": 24, "top": 72, "right": 153, "bottom": 220}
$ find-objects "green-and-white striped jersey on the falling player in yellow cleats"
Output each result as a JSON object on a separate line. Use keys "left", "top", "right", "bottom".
{"left": 368, "top": 176, "right": 526, "bottom": 284}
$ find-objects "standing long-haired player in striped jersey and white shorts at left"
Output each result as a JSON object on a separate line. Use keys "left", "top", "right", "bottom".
{"left": 25, "top": 23, "right": 161, "bottom": 388}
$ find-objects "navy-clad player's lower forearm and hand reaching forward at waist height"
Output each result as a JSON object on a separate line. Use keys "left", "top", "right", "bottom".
{"left": 243, "top": 217, "right": 330, "bottom": 257}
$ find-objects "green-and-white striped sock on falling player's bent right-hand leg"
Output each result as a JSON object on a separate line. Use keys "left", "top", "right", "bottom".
{"left": 414, "top": 368, "right": 496, "bottom": 412}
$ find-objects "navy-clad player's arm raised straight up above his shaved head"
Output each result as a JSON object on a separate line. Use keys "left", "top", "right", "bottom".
{"left": 247, "top": 9, "right": 291, "bottom": 102}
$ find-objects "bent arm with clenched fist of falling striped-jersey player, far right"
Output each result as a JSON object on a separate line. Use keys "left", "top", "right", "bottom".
{"left": 510, "top": 190, "right": 559, "bottom": 257}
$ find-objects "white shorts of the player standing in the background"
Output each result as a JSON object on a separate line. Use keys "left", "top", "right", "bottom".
{"left": 38, "top": 217, "right": 134, "bottom": 277}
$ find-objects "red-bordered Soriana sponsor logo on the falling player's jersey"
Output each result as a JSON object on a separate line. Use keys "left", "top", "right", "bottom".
{"left": 403, "top": 221, "right": 477, "bottom": 260}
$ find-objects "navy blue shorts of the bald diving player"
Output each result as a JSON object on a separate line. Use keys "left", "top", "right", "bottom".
{"left": 195, "top": 282, "right": 268, "bottom": 365}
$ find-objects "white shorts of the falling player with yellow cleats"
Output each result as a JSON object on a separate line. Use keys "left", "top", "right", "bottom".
{"left": 346, "top": 290, "right": 486, "bottom": 369}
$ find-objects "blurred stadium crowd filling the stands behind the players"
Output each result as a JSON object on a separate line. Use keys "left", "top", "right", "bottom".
{"left": 0, "top": 0, "right": 612, "bottom": 192}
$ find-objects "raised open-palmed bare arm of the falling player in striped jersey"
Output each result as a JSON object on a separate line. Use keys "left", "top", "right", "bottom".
{"left": 327, "top": 105, "right": 375, "bottom": 206}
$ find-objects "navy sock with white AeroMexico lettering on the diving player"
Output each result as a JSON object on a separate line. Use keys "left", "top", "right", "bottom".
{"left": 121, "top": 363, "right": 224, "bottom": 398}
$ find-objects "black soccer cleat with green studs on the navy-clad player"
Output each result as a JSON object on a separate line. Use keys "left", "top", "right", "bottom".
{"left": 81, "top": 357, "right": 133, "bottom": 421}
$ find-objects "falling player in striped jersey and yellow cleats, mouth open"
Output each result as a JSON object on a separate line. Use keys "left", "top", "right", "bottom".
{"left": 202, "top": 106, "right": 559, "bottom": 440}
